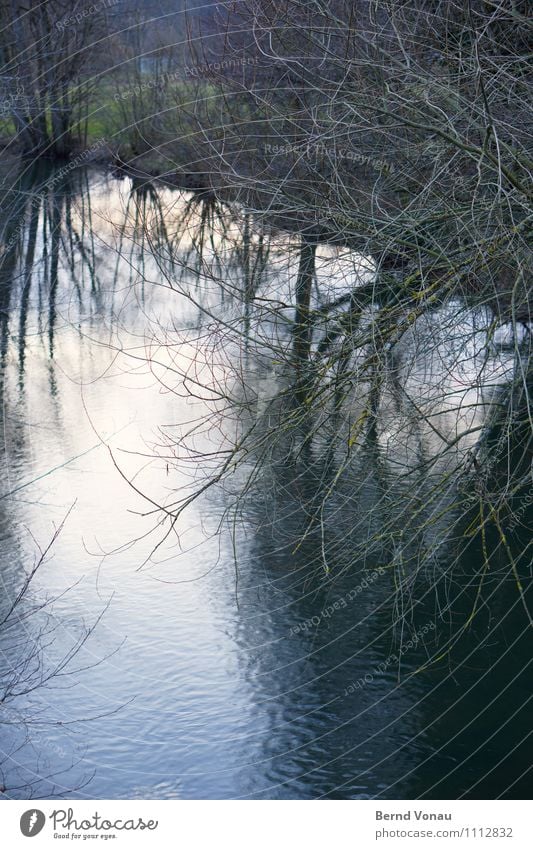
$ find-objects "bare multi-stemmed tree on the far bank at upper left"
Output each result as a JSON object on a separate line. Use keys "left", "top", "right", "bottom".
{"left": 0, "top": 0, "right": 115, "bottom": 158}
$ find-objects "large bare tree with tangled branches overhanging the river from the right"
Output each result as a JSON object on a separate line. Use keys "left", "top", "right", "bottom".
{"left": 111, "top": 0, "right": 533, "bottom": 644}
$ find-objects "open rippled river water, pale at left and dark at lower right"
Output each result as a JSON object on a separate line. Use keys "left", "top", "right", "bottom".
{"left": 0, "top": 162, "right": 532, "bottom": 799}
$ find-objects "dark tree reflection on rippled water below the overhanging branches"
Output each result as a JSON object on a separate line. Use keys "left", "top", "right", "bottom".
{"left": 210, "top": 370, "right": 532, "bottom": 799}
